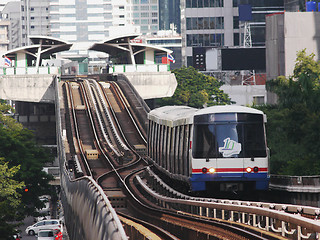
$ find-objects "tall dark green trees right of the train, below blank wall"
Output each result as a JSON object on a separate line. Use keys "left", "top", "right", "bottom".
{"left": 260, "top": 50, "right": 320, "bottom": 175}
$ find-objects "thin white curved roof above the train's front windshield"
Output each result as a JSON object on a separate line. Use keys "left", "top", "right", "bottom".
{"left": 195, "top": 105, "right": 263, "bottom": 115}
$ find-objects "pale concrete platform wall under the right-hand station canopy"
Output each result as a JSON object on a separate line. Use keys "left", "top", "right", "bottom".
{"left": 124, "top": 72, "right": 178, "bottom": 99}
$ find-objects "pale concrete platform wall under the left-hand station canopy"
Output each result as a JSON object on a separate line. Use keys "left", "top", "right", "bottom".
{"left": 0, "top": 74, "right": 56, "bottom": 103}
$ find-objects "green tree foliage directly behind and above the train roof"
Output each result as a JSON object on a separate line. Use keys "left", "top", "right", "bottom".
{"left": 157, "top": 67, "right": 232, "bottom": 108}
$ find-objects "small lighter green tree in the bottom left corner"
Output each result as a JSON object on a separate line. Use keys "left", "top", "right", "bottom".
{"left": 0, "top": 158, "right": 24, "bottom": 239}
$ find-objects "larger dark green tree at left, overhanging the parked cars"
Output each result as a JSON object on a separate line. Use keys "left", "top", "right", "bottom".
{"left": 0, "top": 103, "right": 53, "bottom": 225}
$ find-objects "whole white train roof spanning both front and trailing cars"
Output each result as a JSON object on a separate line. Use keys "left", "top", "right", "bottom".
{"left": 148, "top": 105, "right": 266, "bottom": 127}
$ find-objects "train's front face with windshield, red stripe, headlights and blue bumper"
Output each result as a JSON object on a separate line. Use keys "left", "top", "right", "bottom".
{"left": 190, "top": 106, "right": 269, "bottom": 192}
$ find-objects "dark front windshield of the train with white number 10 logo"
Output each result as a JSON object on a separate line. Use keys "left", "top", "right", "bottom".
{"left": 192, "top": 114, "right": 267, "bottom": 158}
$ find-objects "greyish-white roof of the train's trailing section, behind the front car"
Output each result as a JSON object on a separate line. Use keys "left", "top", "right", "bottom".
{"left": 148, "top": 106, "right": 198, "bottom": 127}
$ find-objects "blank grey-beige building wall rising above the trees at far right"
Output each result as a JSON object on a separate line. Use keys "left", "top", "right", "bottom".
{"left": 266, "top": 12, "right": 320, "bottom": 79}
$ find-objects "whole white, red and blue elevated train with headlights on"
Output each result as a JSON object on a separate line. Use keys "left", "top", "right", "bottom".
{"left": 148, "top": 105, "right": 269, "bottom": 192}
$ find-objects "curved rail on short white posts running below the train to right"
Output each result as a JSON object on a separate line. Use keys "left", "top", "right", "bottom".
{"left": 139, "top": 170, "right": 320, "bottom": 240}
